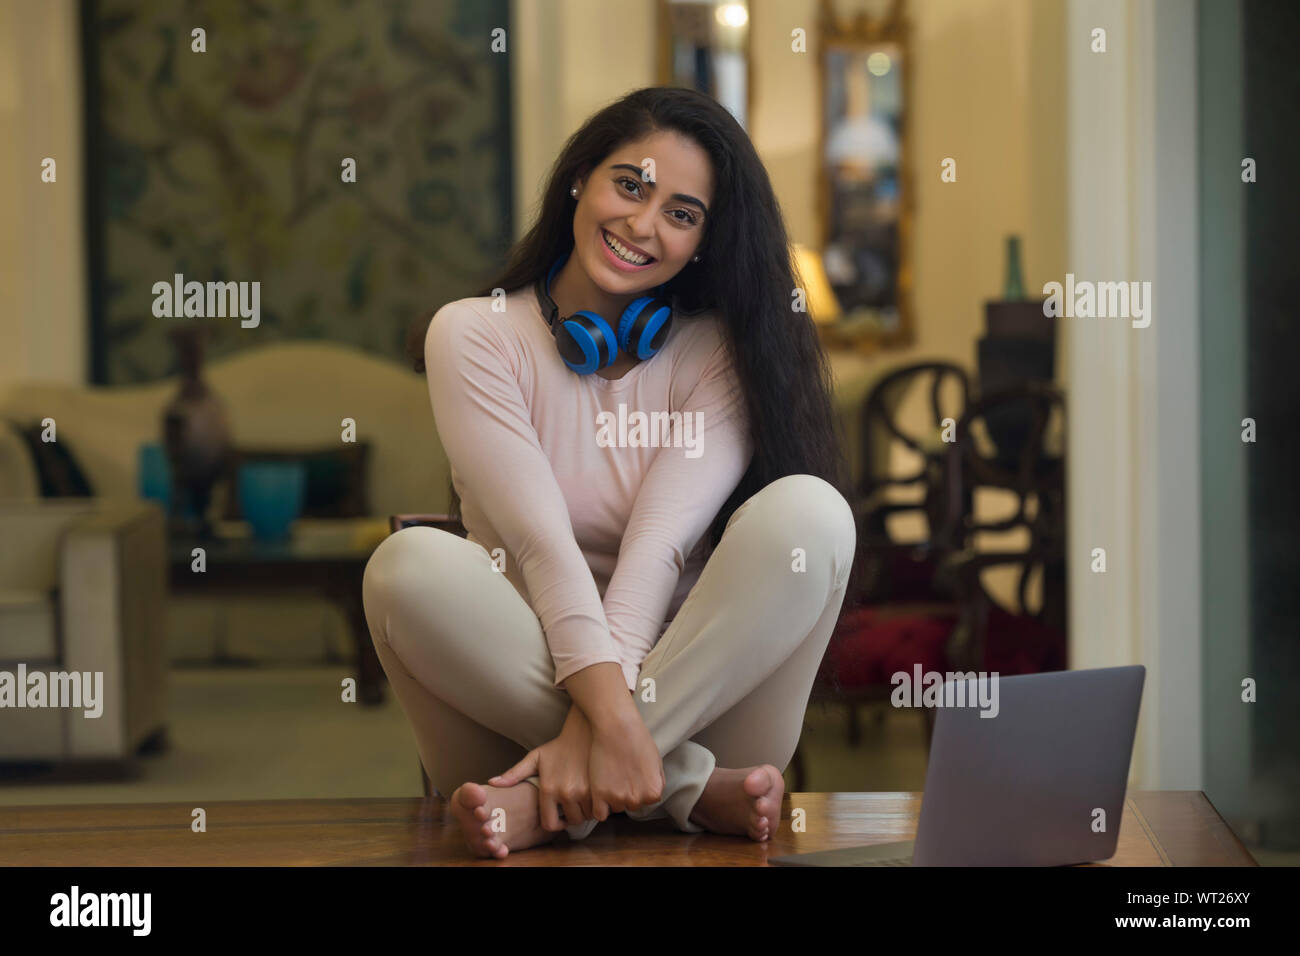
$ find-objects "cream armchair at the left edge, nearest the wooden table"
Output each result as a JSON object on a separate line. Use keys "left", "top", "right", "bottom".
{"left": 0, "top": 498, "right": 166, "bottom": 762}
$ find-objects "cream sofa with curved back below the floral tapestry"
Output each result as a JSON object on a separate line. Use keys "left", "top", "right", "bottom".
{"left": 0, "top": 341, "right": 450, "bottom": 663}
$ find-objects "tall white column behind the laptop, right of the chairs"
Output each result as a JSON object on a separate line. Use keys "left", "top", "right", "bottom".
{"left": 1062, "top": 0, "right": 1201, "bottom": 788}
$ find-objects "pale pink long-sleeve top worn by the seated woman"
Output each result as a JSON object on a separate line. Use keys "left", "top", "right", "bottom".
{"left": 424, "top": 286, "right": 754, "bottom": 689}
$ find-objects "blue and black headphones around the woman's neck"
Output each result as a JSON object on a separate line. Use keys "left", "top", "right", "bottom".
{"left": 533, "top": 250, "right": 672, "bottom": 375}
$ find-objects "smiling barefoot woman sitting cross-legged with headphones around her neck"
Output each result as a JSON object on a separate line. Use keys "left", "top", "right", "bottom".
{"left": 364, "top": 88, "right": 855, "bottom": 858}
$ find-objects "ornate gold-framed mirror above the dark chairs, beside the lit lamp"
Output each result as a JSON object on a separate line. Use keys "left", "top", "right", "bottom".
{"left": 818, "top": 0, "right": 915, "bottom": 351}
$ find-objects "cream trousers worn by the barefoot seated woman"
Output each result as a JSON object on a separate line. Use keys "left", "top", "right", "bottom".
{"left": 363, "top": 475, "right": 855, "bottom": 839}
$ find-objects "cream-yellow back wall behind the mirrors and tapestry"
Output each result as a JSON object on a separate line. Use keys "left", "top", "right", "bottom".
{"left": 0, "top": 0, "right": 1065, "bottom": 395}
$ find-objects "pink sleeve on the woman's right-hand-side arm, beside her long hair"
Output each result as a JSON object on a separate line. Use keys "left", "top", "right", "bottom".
{"left": 603, "top": 325, "right": 754, "bottom": 689}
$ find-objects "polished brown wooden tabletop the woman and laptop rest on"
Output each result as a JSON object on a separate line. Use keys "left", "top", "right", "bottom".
{"left": 0, "top": 791, "right": 1256, "bottom": 866}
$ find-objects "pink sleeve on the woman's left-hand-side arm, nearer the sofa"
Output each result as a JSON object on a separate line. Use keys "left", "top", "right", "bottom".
{"left": 424, "top": 302, "right": 625, "bottom": 704}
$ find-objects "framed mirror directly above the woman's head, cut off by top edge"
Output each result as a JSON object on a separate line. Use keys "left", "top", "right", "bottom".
{"left": 658, "top": 0, "right": 753, "bottom": 131}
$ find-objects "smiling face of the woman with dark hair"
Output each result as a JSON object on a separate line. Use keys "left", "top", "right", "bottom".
{"left": 573, "top": 133, "right": 714, "bottom": 297}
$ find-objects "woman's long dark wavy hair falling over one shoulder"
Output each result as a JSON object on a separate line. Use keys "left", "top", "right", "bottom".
{"left": 407, "top": 87, "right": 861, "bottom": 606}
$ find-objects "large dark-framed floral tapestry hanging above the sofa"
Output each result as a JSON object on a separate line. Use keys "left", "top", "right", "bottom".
{"left": 82, "top": 0, "right": 512, "bottom": 385}
